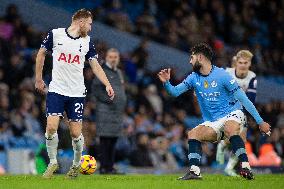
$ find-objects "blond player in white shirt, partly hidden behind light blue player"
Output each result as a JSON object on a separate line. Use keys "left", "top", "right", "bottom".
{"left": 216, "top": 50, "right": 257, "bottom": 176}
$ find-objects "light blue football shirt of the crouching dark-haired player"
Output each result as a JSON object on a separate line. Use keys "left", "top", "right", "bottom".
{"left": 166, "top": 65, "right": 242, "bottom": 121}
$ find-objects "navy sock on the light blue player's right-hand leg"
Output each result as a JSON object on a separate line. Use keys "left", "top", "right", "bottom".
{"left": 230, "top": 135, "right": 248, "bottom": 162}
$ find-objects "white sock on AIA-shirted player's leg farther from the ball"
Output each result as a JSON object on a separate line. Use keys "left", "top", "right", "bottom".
{"left": 45, "top": 133, "right": 58, "bottom": 164}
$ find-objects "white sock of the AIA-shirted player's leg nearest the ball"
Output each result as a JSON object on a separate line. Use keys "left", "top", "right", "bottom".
{"left": 72, "top": 134, "right": 84, "bottom": 167}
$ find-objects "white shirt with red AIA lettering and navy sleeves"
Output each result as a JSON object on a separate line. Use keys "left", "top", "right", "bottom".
{"left": 41, "top": 28, "right": 98, "bottom": 97}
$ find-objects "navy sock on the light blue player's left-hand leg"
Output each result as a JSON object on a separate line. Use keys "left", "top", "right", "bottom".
{"left": 188, "top": 139, "right": 202, "bottom": 166}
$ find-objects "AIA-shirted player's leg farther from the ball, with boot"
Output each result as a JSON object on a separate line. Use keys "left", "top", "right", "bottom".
{"left": 43, "top": 116, "right": 60, "bottom": 178}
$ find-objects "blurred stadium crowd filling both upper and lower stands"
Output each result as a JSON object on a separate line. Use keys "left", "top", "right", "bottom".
{"left": 0, "top": 0, "right": 284, "bottom": 173}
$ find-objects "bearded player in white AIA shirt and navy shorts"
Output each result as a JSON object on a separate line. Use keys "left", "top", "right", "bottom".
{"left": 35, "top": 9, "right": 114, "bottom": 178}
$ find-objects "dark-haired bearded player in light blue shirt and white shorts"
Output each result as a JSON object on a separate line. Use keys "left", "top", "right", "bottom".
{"left": 158, "top": 43, "right": 270, "bottom": 180}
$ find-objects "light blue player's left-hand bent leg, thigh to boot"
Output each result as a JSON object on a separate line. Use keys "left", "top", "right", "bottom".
{"left": 178, "top": 125, "right": 217, "bottom": 180}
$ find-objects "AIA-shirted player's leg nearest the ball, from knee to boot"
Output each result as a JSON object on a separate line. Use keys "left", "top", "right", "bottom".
{"left": 67, "top": 121, "right": 84, "bottom": 178}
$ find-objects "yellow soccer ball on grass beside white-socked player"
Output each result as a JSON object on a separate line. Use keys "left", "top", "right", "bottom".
{"left": 80, "top": 155, "right": 97, "bottom": 175}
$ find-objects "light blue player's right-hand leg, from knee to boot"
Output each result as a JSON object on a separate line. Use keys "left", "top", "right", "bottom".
{"left": 224, "top": 120, "right": 254, "bottom": 180}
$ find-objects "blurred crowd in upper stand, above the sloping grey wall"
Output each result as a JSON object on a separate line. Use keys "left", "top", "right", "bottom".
{"left": 93, "top": 0, "right": 284, "bottom": 74}
